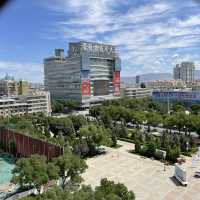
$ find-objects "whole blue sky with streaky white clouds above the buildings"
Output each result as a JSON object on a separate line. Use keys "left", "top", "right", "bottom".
{"left": 0, "top": 0, "right": 200, "bottom": 82}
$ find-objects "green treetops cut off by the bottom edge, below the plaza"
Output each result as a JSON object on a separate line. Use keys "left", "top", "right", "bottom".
{"left": 21, "top": 179, "right": 135, "bottom": 200}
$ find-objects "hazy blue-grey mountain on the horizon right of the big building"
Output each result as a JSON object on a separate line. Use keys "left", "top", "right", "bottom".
{"left": 122, "top": 73, "right": 173, "bottom": 85}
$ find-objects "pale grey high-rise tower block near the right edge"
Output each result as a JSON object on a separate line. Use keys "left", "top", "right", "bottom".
{"left": 174, "top": 62, "right": 195, "bottom": 83}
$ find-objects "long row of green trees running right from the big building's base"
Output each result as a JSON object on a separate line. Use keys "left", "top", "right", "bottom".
{"left": 90, "top": 105, "right": 200, "bottom": 134}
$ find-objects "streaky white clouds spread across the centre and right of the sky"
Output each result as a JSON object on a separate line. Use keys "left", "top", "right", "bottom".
{"left": 41, "top": 0, "right": 200, "bottom": 75}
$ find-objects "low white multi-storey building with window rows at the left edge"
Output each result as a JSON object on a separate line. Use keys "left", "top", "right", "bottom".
{"left": 0, "top": 92, "right": 51, "bottom": 117}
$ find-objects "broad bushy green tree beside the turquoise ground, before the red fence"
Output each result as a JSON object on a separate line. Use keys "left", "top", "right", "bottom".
{"left": 12, "top": 155, "right": 58, "bottom": 192}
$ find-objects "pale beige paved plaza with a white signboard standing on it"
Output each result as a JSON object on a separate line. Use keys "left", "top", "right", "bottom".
{"left": 83, "top": 141, "right": 200, "bottom": 200}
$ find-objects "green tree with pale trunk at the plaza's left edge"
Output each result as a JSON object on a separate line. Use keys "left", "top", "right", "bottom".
{"left": 54, "top": 152, "right": 87, "bottom": 188}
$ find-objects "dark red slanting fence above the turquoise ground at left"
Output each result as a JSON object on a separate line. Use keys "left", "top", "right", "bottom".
{"left": 0, "top": 129, "right": 64, "bottom": 159}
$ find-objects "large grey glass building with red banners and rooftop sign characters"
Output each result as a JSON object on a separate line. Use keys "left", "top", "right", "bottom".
{"left": 44, "top": 41, "right": 121, "bottom": 106}
